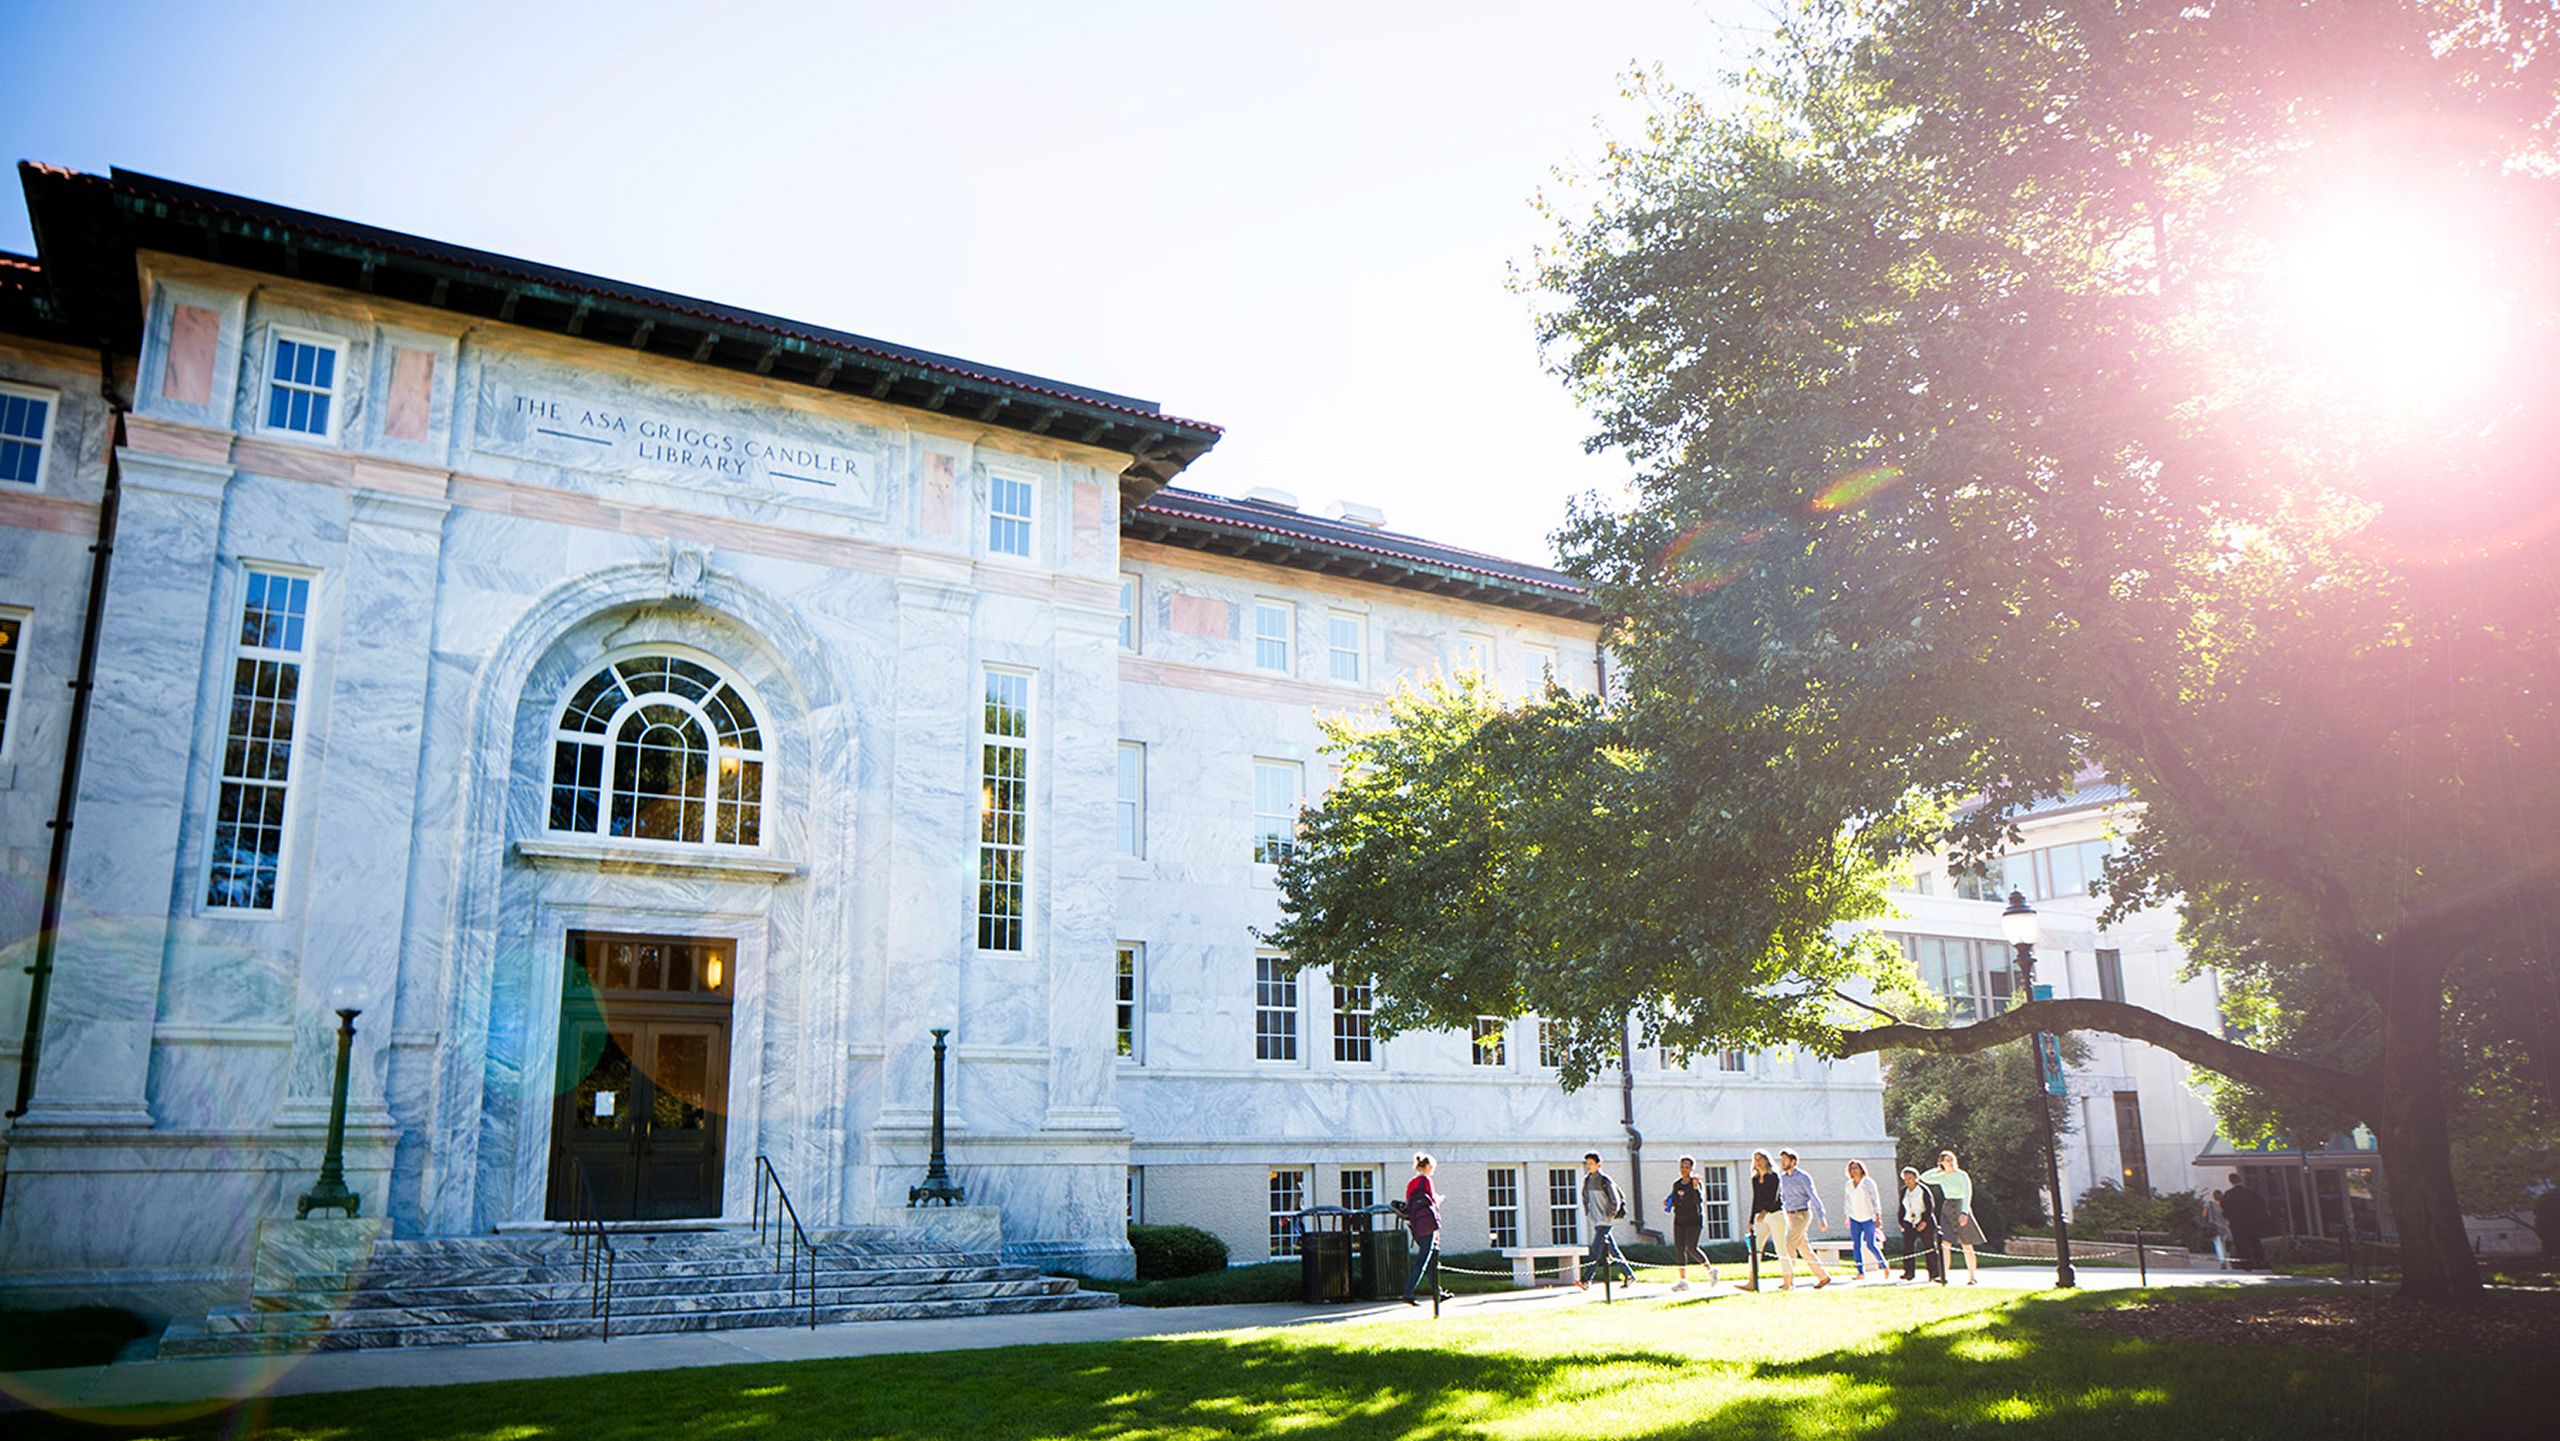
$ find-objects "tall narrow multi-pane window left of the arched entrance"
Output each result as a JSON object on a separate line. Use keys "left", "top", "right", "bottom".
{"left": 205, "top": 571, "right": 312, "bottom": 911}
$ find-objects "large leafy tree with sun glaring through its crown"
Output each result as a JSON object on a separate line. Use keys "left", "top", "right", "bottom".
{"left": 1280, "top": 0, "right": 2560, "bottom": 1295}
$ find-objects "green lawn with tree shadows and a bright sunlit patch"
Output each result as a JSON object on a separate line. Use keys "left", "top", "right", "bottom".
{"left": 10, "top": 1287, "right": 2560, "bottom": 1441}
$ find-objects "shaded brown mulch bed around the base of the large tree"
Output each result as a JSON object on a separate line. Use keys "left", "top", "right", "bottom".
{"left": 2076, "top": 1293, "right": 2560, "bottom": 1357}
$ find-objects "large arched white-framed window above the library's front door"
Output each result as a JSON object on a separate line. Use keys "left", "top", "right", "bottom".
{"left": 550, "top": 655, "right": 765, "bottom": 845}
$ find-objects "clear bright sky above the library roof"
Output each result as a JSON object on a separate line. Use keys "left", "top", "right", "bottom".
{"left": 0, "top": 0, "right": 1764, "bottom": 558}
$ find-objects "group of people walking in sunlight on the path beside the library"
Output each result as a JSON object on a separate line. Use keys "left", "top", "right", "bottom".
{"left": 1403, "top": 1147, "right": 1986, "bottom": 1305}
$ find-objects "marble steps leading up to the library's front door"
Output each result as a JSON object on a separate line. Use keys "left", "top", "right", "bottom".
{"left": 159, "top": 1229, "right": 1119, "bottom": 1359}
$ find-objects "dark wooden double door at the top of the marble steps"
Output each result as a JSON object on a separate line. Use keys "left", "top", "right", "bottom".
{"left": 548, "top": 932, "right": 737, "bottom": 1221}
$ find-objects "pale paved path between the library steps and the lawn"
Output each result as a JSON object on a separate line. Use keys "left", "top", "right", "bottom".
{"left": 0, "top": 1267, "right": 2324, "bottom": 1413}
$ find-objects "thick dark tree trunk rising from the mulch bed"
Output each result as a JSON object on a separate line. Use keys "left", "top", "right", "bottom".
{"left": 2373, "top": 967, "right": 2481, "bottom": 1300}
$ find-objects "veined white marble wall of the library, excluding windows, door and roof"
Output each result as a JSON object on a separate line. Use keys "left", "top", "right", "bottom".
{"left": 0, "top": 199, "right": 1887, "bottom": 1313}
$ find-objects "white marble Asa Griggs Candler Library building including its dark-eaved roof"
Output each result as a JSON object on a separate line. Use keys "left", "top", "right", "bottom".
{"left": 0, "top": 166, "right": 1887, "bottom": 1313}
